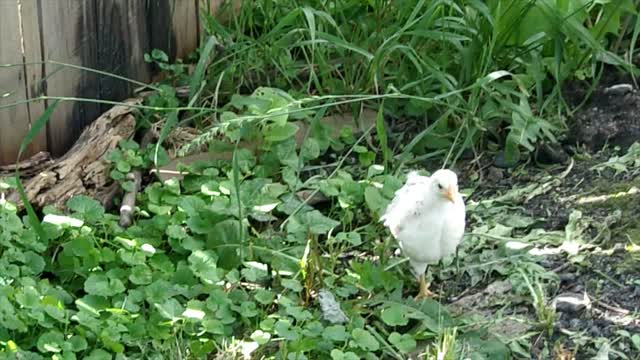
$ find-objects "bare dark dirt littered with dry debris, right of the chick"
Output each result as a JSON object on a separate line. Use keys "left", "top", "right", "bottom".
{"left": 396, "top": 69, "right": 640, "bottom": 359}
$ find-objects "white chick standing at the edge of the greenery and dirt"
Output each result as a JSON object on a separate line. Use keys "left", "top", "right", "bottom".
{"left": 380, "top": 169, "right": 465, "bottom": 299}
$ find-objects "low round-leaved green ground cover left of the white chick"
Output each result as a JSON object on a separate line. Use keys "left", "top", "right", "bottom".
{"left": 0, "top": 125, "right": 512, "bottom": 359}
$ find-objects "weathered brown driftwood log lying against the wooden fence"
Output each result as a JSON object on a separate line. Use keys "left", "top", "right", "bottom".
{"left": 8, "top": 99, "right": 142, "bottom": 209}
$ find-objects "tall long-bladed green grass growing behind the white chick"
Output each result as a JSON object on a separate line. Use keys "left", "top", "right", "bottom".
{"left": 194, "top": 0, "right": 637, "bottom": 163}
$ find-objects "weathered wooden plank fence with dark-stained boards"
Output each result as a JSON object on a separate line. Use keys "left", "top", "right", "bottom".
{"left": 0, "top": 0, "right": 232, "bottom": 165}
